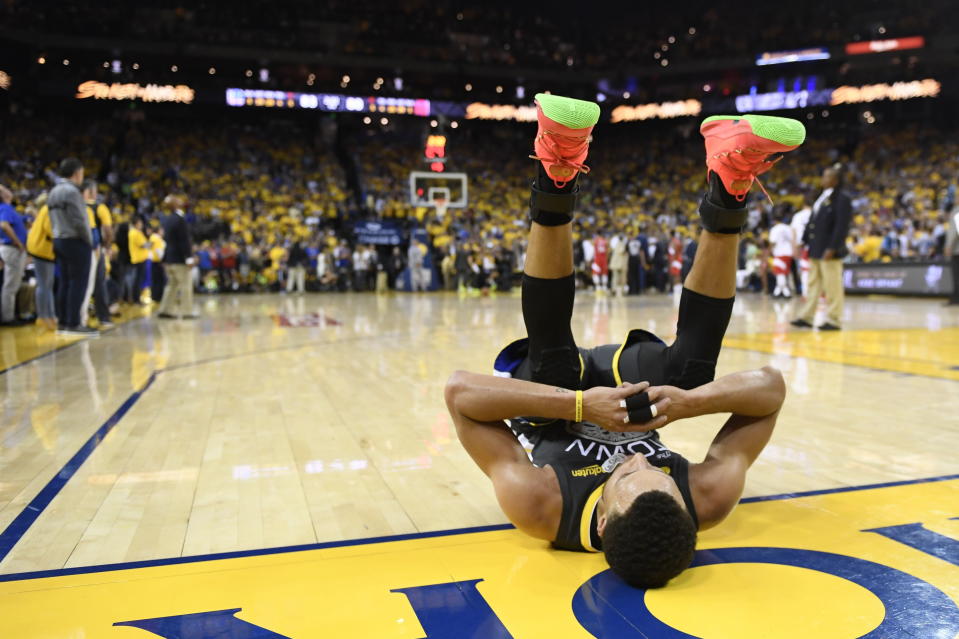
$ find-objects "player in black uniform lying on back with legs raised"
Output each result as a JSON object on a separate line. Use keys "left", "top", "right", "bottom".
{"left": 446, "top": 95, "right": 805, "bottom": 587}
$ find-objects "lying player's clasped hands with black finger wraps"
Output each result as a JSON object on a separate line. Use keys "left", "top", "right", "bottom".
{"left": 583, "top": 382, "right": 679, "bottom": 432}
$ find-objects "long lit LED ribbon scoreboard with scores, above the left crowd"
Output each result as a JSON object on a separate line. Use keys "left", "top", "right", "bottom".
{"left": 226, "top": 88, "right": 431, "bottom": 117}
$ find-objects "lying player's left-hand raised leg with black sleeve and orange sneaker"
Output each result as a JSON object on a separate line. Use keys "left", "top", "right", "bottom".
{"left": 522, "top": 94, "right": 599, "bottom": 388}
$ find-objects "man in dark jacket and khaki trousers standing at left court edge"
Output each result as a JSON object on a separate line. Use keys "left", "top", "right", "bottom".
{"left": 157, "top": 195, "right": 196, "bottom": 319}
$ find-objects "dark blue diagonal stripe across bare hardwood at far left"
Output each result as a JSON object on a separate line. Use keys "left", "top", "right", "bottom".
{"left": 0, "top": 371, "right": 158, "bottom": 561}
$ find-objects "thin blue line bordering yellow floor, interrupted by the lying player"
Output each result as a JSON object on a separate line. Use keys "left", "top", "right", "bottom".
{"left": 0, "top": 474, "right": 959, "bottom": 583}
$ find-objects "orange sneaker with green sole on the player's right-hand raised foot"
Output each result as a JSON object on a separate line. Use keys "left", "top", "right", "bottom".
{"left": 699, "top": 114, "right": 806, "bottom": 202}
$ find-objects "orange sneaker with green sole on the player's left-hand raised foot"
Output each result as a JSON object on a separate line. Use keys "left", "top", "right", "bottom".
{"left": 530, "top": 93, "right": 599, "bottom": 188}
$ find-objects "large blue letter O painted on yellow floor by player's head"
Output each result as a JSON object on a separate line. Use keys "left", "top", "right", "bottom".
{"left": 573, "top": 547, "right": 959, "bottom": 639}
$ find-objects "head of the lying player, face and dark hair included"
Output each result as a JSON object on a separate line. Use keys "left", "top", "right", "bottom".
{"left": 597, "top": 455, "right": 696, "bottom": 588}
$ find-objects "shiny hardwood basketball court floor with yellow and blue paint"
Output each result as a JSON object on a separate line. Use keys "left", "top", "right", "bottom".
{"left": 0, "top": 293, "right": 959, "bottom": 639}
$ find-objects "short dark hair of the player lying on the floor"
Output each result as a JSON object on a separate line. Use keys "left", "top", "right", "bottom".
{"left": 603, "top": 490, "right": 696, "bottom": 588}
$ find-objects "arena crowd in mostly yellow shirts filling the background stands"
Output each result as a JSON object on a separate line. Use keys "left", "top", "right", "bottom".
{"left": 0, "top": 111, "right": 959, "bottom": 328}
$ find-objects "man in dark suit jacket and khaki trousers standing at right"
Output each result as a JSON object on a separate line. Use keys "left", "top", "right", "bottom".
{"left": 792, "top": 164, "right": 852, "bottom": 331}
